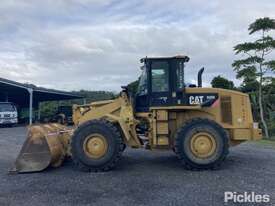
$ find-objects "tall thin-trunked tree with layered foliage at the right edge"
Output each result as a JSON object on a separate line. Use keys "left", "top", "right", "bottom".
{"left": 232, "top": 17, "right": 275, "bottom": 138}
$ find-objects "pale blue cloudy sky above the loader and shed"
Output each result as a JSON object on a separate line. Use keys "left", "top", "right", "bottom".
{"left": 0, "top": 0, "right": 275, "bottom": 91}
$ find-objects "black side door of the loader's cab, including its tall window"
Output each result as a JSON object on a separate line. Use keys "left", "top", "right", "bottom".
{"left": 149, "top": 60, "right": 171, "bottom": 106}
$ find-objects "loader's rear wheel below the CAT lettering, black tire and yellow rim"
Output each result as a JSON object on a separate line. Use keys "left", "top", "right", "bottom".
{"left": 175, "top": 118, "right": 229, "bottom": 170}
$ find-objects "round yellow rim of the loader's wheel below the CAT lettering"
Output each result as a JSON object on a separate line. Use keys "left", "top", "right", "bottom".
{"left": 191, "top": 132, "right": 217, "bottom": 158}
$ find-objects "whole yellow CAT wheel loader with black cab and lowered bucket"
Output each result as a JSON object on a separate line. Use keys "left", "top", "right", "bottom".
{"left": 12, "top": 56, "right": 262, "bottom": 173}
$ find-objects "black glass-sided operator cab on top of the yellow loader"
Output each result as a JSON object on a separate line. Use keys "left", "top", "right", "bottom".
{"left": 135, "top": 56, "right": 189, "bottom": 112}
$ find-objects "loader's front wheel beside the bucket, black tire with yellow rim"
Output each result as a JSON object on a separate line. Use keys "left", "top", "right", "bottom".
{"left": 71, "top": 119, "right": 124, "bottom": 172}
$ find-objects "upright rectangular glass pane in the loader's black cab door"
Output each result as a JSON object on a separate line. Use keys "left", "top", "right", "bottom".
{"left": 151, "top": 61, "right": 169, "bottom": 92}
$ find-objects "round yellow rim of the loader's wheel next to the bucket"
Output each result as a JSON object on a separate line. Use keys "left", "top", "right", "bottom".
{"left": 83, "top": 134, "right": 108, "bottom": 159}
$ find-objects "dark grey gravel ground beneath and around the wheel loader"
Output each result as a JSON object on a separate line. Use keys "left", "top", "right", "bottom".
{"left": 0, "top": 127, "right": 275, "bottom": 206}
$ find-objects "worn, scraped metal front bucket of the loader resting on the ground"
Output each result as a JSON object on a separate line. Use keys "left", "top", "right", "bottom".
{"left": 10, "top": 124, "right": 73, "bottom": 173}
